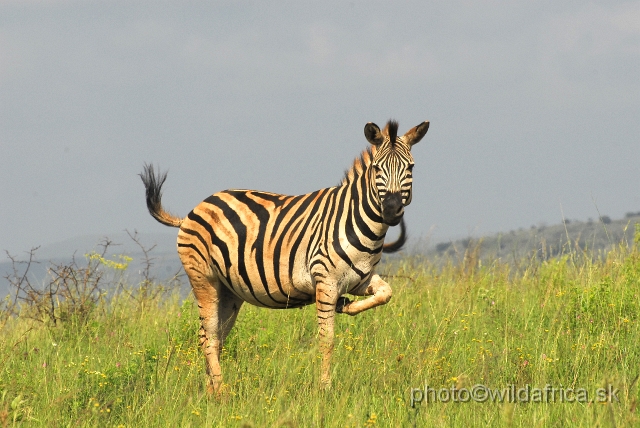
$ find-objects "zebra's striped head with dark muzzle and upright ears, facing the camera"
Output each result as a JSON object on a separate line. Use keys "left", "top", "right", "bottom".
{"left": 364, "top": 120, "right": 429, "bottom": 226}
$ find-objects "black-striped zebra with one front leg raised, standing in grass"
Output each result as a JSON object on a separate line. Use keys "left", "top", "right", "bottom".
{"left": 140, "top": 120, "right": 429, "bottom": 393}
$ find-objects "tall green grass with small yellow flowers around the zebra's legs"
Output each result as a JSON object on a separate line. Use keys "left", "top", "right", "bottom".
{"left": 0, "top": 242, "right": 640, "bottom": 427}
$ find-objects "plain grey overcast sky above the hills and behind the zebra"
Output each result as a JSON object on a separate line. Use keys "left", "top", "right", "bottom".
{"left": 0, "top": 0, "right": 640, "bottom": 254}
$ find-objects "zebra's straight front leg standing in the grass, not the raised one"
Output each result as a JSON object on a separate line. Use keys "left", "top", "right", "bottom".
{"left": 316, "top": 282, "right": 338, "bottom": 389}
